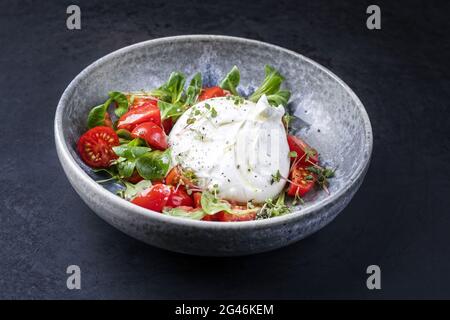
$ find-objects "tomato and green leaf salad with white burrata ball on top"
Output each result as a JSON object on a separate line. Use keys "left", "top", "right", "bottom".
{"left": 77, "top": 66, "right": 334, "bottom": 222}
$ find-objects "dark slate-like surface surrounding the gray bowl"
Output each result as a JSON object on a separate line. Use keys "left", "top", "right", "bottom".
{"left": 0, "top": 0, "right": 450, "bottom": 299}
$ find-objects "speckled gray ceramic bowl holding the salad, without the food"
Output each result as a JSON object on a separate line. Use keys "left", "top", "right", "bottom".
{"left": 55, "top": 35, "right": 372, "bottom": 256}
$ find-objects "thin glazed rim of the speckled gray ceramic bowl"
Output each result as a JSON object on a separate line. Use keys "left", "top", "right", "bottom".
{"left": 54, "top": 34, "right": 373, "bottom": 230}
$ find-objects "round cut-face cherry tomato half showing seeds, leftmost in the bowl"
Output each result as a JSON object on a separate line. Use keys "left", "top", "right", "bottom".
{"left": 77, "top": 127, "right": 119, "bottom": 168}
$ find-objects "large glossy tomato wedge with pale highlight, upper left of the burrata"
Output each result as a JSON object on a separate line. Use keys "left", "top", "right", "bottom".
{"left": 117, "top": 104, "right": 161, "bottom": 131}
